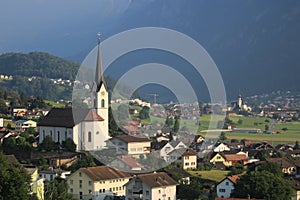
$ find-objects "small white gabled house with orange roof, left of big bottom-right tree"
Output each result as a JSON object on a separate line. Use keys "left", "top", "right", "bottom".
{"left": 217, "top": 175, "right": 239, "bottom": 198}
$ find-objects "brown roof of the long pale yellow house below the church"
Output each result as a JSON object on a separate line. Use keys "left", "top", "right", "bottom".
{"left": 79, "top": 166, "right": 131, "bottom": 181}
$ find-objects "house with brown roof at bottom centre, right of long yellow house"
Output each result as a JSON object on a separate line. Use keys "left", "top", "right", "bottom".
{"left": 125, "top": 172, "right": 177, "bottom": 200}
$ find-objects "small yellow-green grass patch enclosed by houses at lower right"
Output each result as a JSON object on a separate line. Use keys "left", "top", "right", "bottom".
{"left": 189, "top": 170, "right": 229, "bottom": 182}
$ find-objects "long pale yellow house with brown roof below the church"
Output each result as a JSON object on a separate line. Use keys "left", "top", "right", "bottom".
{"left": 67, "top": 166, "right": 131, "bottom": 200}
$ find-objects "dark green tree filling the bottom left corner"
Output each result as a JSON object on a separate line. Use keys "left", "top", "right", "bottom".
{"left": 0, "top": 153, "right": 31, "bottom": 200}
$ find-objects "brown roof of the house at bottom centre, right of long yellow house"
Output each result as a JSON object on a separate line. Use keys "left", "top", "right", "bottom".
{"left": 137, "top": 172, "right": 177, "bottom": 188}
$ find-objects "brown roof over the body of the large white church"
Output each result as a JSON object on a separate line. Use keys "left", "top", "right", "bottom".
{"left": 38, "top": 108, "right": 104, "bottom": 128}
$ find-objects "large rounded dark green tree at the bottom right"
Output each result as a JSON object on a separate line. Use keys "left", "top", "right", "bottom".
{"left": 233, "top": 171, "right": 292, "bottom": 200}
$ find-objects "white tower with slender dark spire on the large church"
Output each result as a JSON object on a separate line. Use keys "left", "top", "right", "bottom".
{"left": 93, "top": 33, "right": 109, "bottom": 139}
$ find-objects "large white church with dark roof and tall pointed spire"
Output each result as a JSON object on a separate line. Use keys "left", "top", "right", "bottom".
{"left": 38, "top": 33, "right": 110, "bottom": 151}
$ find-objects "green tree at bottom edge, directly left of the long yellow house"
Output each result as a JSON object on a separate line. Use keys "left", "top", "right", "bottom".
{"left": 45, "top": 179, "right": 73, "bottom": 200}
